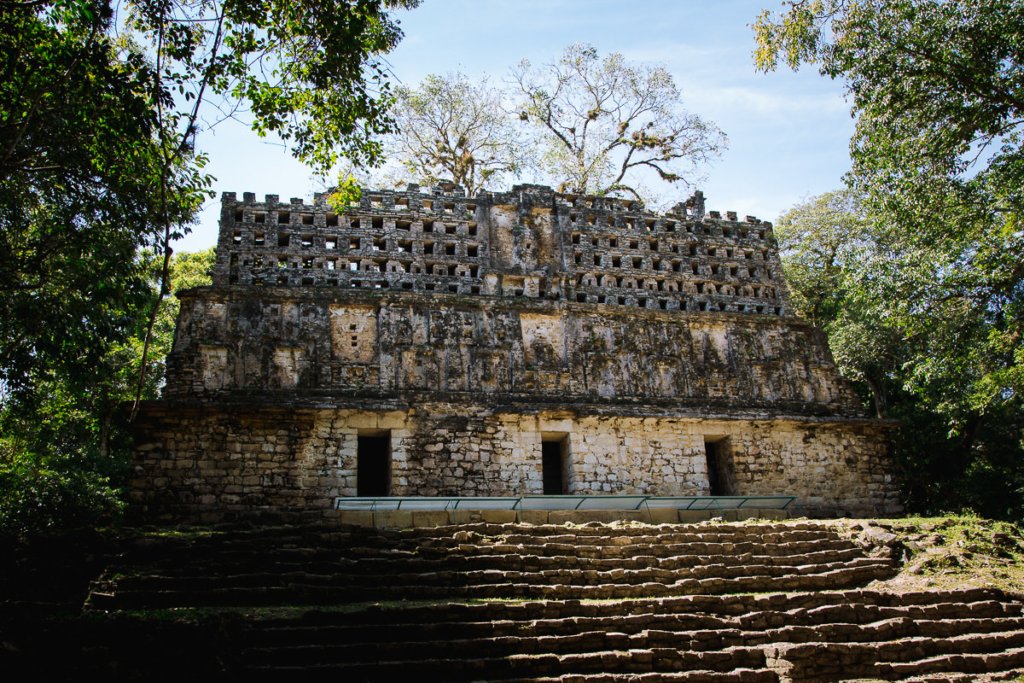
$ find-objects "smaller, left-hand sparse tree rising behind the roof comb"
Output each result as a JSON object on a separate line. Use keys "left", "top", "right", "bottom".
{"left": 385, "top": 74, "right": 525, "bottom": 197}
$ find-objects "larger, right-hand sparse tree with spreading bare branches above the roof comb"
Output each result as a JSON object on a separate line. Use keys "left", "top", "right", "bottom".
{"left": 513, "top": 45, "right": 725, "bottom": 198}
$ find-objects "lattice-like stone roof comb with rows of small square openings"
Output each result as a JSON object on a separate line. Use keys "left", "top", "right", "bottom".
{"left": 214, "top": 185, "right": 787, "bottom": 315}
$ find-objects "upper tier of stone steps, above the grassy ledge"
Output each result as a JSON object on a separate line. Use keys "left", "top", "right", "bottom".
{"left": 83, "top": 524, "right": 894, "bottom": 609}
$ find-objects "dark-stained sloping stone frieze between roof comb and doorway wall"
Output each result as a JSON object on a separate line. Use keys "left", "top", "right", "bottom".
{"left": 166, "top": 287, "right": 860, "bottom": 415}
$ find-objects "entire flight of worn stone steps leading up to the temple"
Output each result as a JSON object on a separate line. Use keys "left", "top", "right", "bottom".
{"left": 59, "top": 522, "right": 1024, "bottom": 683}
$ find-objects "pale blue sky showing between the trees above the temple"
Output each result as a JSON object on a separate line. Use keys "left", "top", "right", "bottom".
{"left": 175, "top": 0, "right": 853, "bottom": 251}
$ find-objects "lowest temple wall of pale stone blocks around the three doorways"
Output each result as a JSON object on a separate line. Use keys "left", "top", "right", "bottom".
{"left": 131, "top": 402, "right": 898, "bottom": 517}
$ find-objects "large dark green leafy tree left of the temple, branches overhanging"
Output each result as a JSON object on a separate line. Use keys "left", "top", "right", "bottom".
{"left": 0, "top": 0, "right": 416, "bottom": 532}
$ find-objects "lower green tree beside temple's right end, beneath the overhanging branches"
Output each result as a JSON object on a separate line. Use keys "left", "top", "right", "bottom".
{"left": 776, "top": 190, "right": 1024, "bottom": 519}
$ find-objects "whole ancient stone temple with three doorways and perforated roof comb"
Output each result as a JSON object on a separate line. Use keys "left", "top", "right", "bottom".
{"left": 132, "top": 185, "right": 898, "bottom": 516}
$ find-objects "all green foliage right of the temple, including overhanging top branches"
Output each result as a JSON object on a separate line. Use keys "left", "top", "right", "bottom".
{"left": 755, "top": 0, "right": 1024, "bottom": 517}
